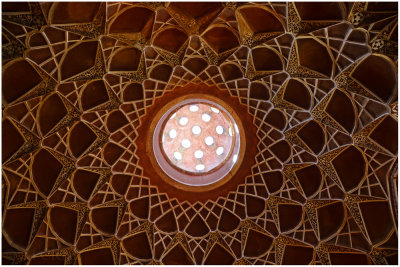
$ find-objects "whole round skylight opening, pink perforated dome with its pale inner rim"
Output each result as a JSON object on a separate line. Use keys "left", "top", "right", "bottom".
{"left": 153, "top": 99, "right": 240, "bottom": 186}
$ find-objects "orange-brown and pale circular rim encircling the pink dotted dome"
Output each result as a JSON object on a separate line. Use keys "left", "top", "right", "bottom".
{"left": 147, "top": 94, "right": 245, "bottom": 191}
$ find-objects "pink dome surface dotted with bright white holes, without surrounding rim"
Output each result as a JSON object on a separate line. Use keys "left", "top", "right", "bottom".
{"left": 162, "top": 103, "right": 235, "bottom": 174}
